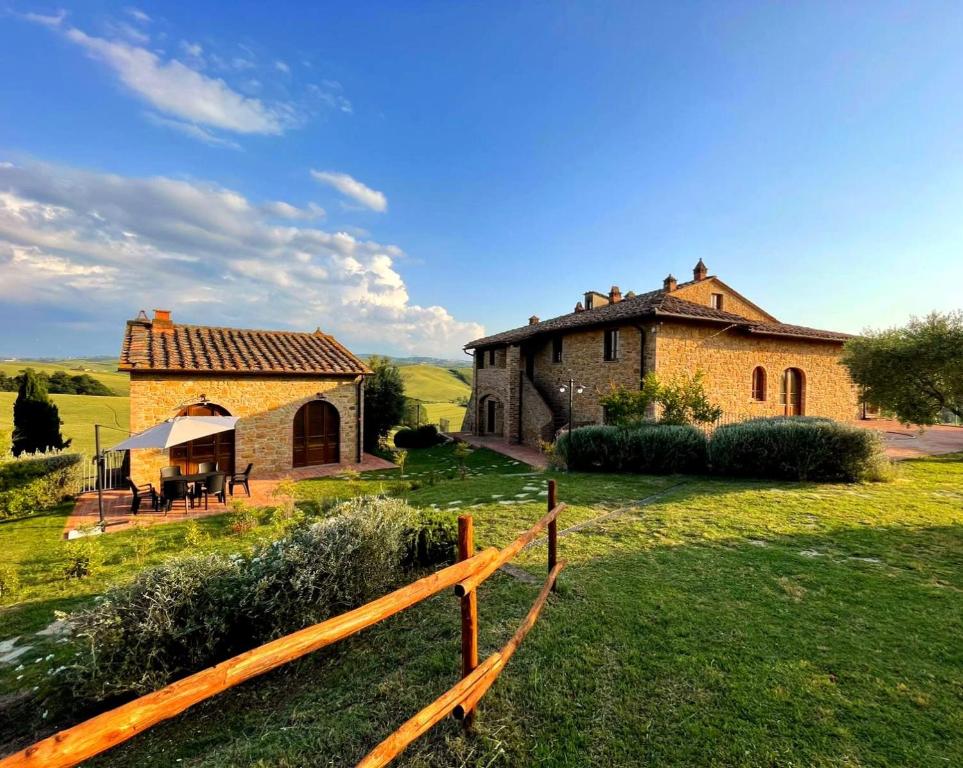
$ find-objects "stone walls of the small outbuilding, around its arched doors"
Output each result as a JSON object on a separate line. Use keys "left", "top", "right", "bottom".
{"left": 130, "top": 372, "right": 363, "bottom": 483}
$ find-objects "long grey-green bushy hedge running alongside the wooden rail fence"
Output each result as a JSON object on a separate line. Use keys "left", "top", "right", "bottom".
{"left": 64, "top": 497, "right": 448, "bottom": 704}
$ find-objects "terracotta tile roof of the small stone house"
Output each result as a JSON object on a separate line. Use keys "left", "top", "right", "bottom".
{"left": 119, "top": 320, "right": 371, "bottom": 375}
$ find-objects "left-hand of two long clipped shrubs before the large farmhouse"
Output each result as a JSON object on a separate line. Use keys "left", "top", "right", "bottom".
{"left": 555, "top": 424, "right": 706, "bottom": 475}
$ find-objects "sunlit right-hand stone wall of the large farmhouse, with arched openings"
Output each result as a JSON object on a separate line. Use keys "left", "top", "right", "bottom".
{"left": 655, "top": 322, "right": 858, "bottom": 422}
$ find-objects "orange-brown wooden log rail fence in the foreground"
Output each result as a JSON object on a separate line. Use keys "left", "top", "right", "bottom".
{"left": 0, "top": 480, "right": 565, "bottom": 768}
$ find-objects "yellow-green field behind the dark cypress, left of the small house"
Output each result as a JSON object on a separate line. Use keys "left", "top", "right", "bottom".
{"left": 0, "top": 392, "right": 130, "bottom": 454}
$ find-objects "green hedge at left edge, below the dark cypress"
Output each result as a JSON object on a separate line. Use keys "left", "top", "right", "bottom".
{"left": 0, "top": 453, "right": 80, "bottom": 518}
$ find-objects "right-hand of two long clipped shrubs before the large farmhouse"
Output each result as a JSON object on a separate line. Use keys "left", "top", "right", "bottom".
{"left": 709, "top": 416, "right": 883, "bottom": 482}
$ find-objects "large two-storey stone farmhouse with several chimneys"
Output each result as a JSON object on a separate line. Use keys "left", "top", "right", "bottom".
{"left": 462, "top": 259, "right": 858, "bottom": 446}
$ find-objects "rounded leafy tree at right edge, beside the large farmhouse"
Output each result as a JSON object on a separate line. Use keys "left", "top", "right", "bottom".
{"left": 843, "top": 311, "right": 963, "bottom": 425}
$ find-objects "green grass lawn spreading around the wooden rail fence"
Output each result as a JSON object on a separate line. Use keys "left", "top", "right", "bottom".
{"left": 0, "top": 447, "right": 963, "bottom": 768}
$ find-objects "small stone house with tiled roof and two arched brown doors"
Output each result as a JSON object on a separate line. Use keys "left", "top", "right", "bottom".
{"left": 119, "top": 310, "right": 371, "bottom": 483}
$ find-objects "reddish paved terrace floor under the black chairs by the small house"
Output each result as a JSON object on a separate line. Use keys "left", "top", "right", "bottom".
{"left": 64, "top": 453, "right": 395, "bottom": 538}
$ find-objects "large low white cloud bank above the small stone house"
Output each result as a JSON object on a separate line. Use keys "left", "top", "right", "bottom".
{"left": 0, "top": 164, "right": 484, "bottom": 355}
